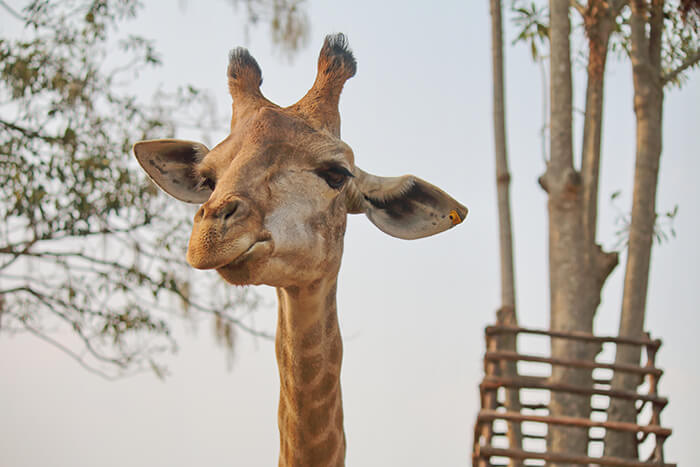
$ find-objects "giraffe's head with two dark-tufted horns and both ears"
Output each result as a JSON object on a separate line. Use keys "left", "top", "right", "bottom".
{"left": 134, "top": 34, "right": 467, "bottom": 287}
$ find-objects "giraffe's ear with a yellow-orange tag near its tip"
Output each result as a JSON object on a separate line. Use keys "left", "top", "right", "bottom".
{"left": 348, "top": 167, "right": 468, "bottom": 240}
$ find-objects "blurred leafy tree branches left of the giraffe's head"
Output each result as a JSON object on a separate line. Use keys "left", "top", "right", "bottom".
{"left": 0, "top": 0, "right": 296, "bottom": 377}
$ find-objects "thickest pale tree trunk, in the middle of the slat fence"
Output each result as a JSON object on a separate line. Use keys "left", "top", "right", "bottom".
{"left": 540, "top": 0, "right": 593, "bottom": 465}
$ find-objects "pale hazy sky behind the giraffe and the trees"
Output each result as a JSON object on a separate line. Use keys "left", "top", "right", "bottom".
{"left": 0, "top": 0, "right": 700, "bottom": 467}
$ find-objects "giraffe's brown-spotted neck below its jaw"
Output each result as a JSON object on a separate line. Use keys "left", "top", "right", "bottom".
{"left": 275, "top": 277, "right": 345, "bottom": 467}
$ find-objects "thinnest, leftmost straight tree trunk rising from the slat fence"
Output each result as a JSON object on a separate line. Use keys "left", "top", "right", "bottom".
{"left": 490, "top": 0, "right": 522, "bottom": 460}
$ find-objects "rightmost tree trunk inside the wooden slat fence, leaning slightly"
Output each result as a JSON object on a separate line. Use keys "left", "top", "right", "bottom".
{"left": 605, "top": 0, "right": 663, "bottom": 458}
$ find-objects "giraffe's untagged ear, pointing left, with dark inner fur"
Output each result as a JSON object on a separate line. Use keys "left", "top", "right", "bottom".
{"left": 134, "top": 139, "right": 212, "bottom": 204}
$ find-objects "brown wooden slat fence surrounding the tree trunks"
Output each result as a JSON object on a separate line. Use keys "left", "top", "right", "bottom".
{"left": 472, "top": 324, "right": 676, "bottom": 467}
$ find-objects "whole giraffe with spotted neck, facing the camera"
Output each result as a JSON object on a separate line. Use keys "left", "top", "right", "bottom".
{"left": 134, "top": 34, "right": 467, "bottom": 467}
